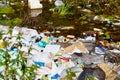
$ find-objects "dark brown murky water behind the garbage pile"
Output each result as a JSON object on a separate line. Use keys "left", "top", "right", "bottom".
{"left": 1, "top": 1, "right": 120, "bottom": 36}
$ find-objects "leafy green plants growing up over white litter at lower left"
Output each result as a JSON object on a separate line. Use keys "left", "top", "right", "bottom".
{"left": 0, "top": 29, "right": 38, "bottom": 80}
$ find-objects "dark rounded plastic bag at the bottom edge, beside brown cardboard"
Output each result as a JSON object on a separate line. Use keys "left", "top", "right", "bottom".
{"left": 77, "top": 66, "right": 106, "bottom": 80}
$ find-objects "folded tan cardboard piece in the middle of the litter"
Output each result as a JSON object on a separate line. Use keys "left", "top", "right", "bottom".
{"left": 65, "top": 42, "right": 88, "bottom": 53}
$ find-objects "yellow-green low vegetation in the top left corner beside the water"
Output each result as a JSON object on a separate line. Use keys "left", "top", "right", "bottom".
{"left": 0, "top": 0, "right": 22, "bottom": 27}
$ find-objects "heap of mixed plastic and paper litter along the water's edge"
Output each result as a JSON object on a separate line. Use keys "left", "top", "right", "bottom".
{"left": 0, "top": 25, "right": 120, "bottom": 80}
